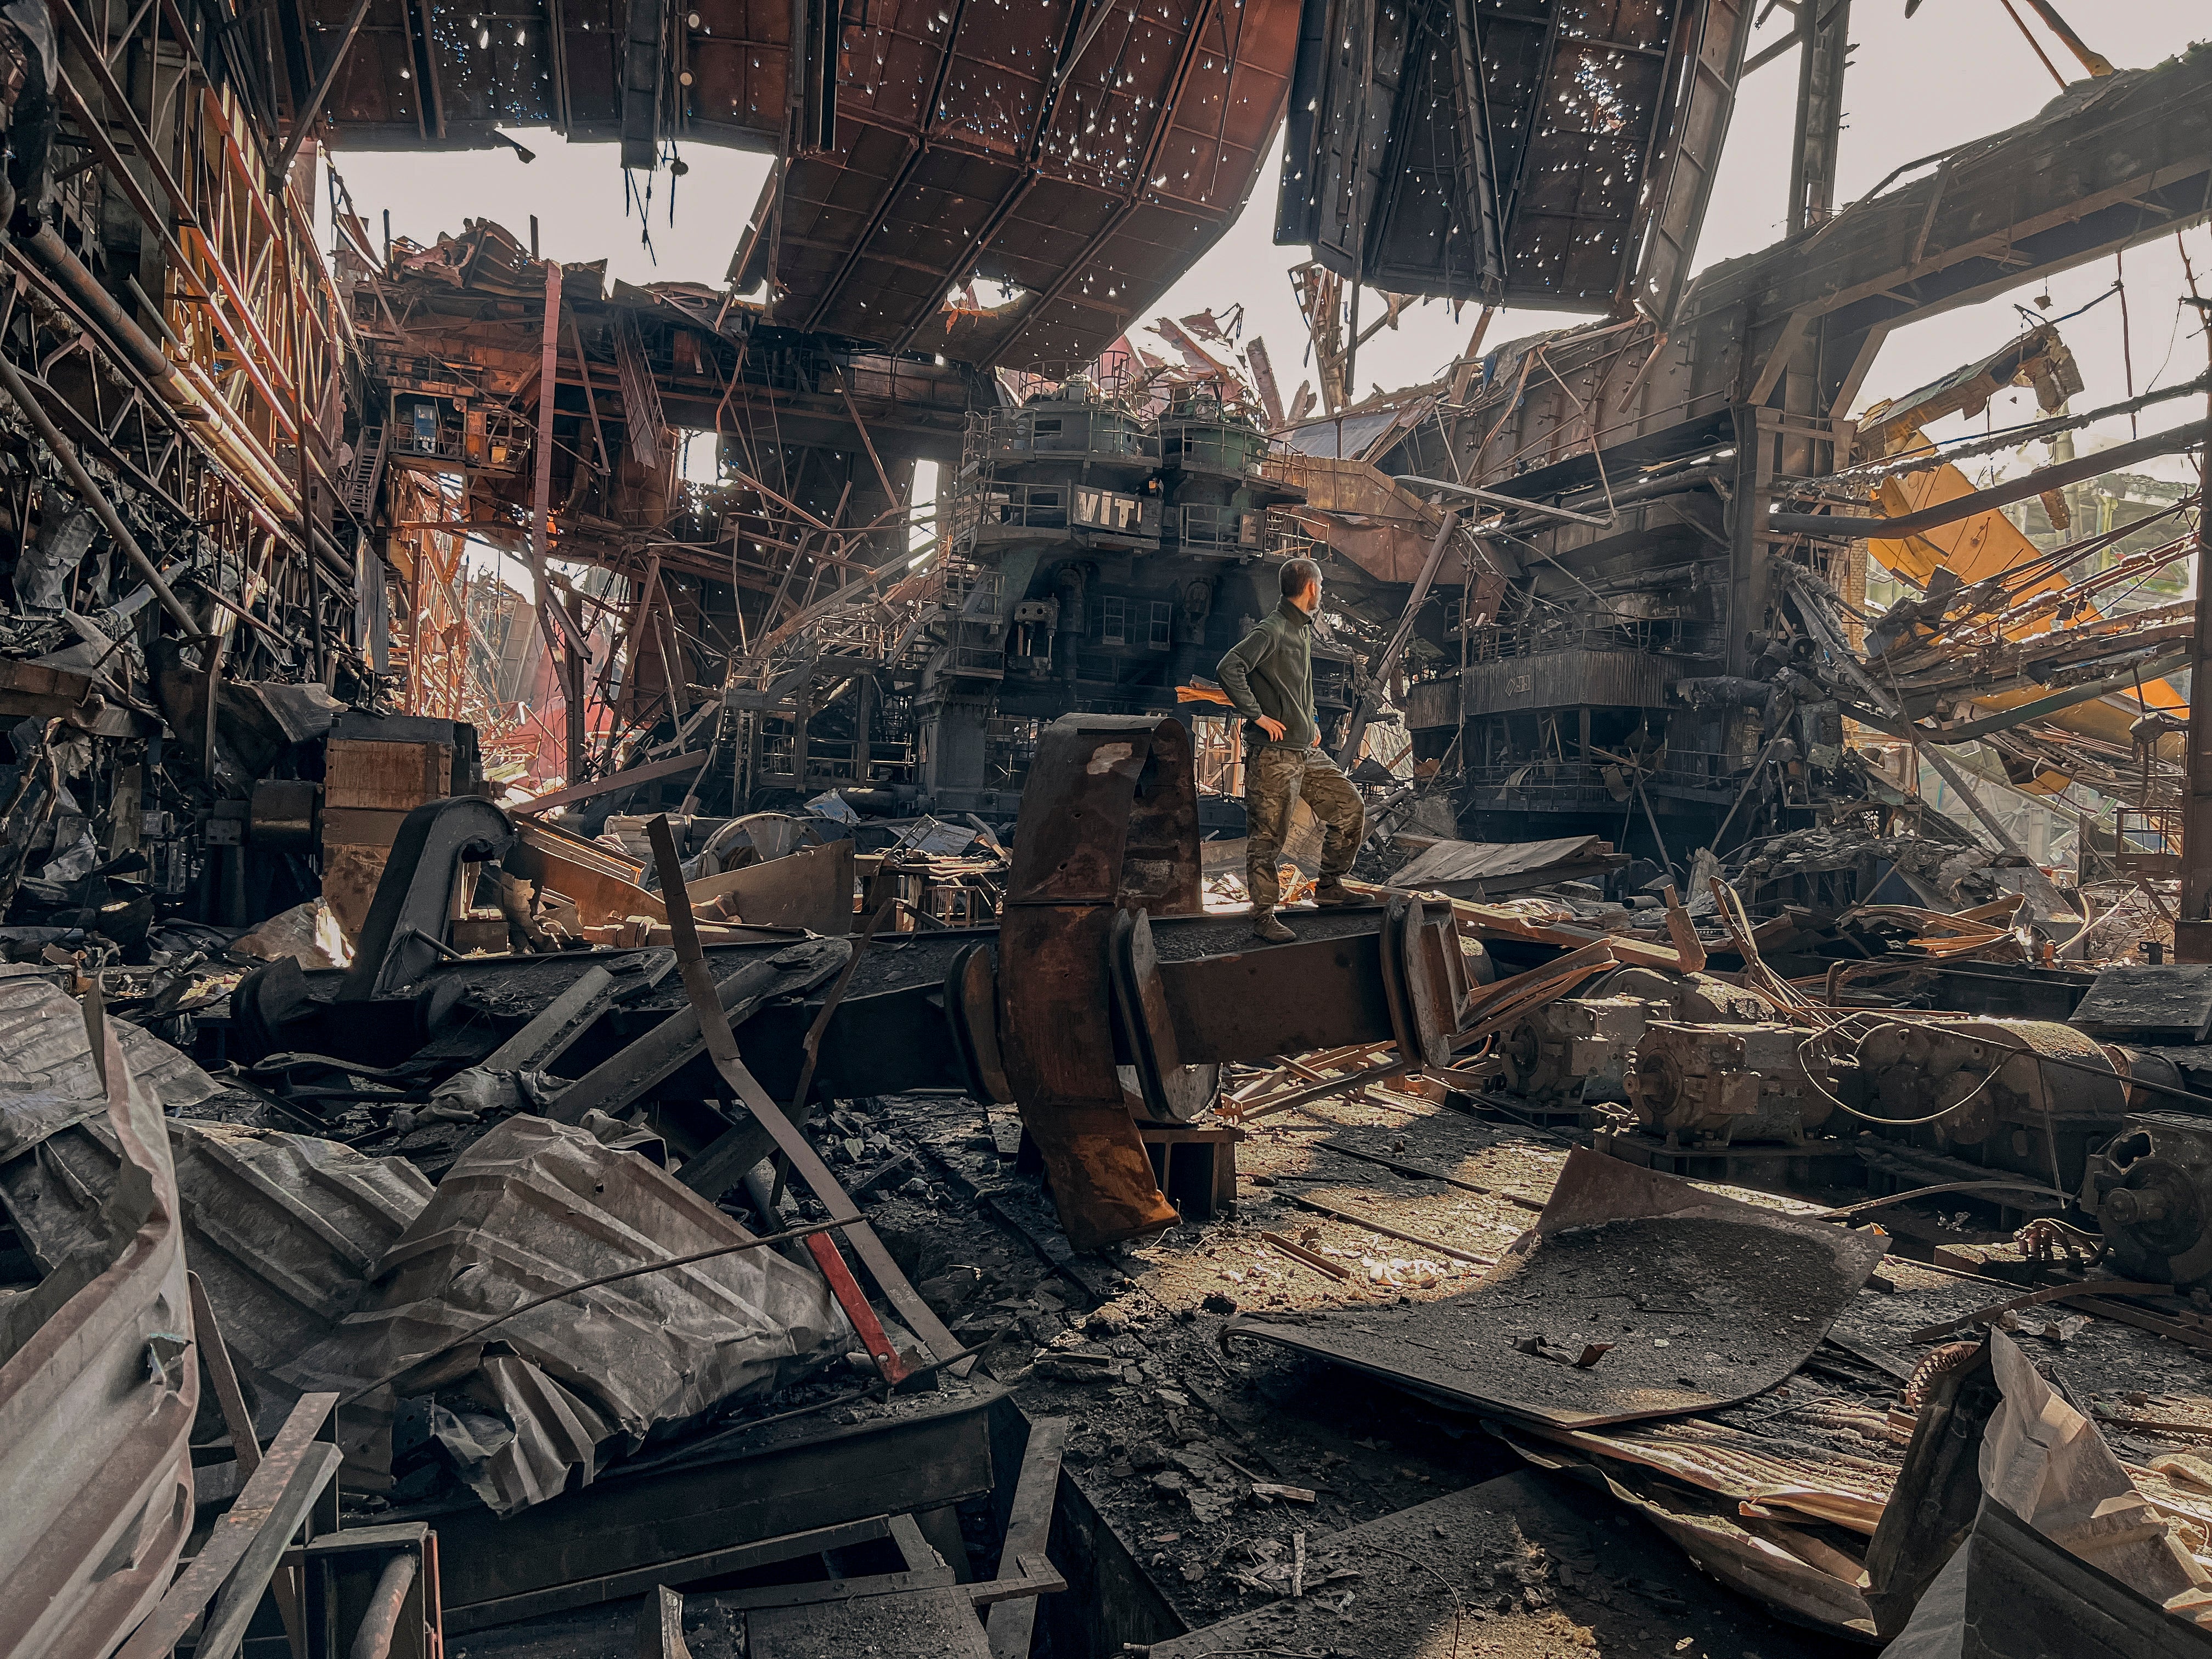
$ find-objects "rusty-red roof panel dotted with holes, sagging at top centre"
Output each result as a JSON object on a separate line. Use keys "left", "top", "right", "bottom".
{"left": 737, "top": 0, "right": 1296, "bottom": 365}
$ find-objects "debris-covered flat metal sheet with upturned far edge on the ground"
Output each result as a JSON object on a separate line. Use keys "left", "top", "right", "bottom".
{"left": 1223, "top": 1148, "right": 1887, "bottom": 1429}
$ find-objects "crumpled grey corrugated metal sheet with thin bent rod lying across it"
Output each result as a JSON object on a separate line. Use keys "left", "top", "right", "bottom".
{"left": 296, "top": 1117, "right": 851, "bottom": 1515}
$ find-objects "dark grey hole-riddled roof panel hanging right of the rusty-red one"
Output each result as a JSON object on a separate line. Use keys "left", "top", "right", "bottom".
{"left": 1276, "top": 0, "right": 1750, "bottom": 312}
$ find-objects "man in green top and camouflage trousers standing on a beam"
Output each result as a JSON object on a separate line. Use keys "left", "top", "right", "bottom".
{"left": 1217, "top": 560, "right": 1367, "bottom": 945}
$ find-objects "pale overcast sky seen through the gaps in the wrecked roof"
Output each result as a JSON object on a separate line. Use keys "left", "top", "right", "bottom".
{"left": 336, "top": 0, "right": 2212, "bottom": 473}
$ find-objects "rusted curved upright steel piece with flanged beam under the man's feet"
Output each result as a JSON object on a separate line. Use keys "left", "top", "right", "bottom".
{"left": 997, "top": 714, "right": 1466, "bottom": 1250}
